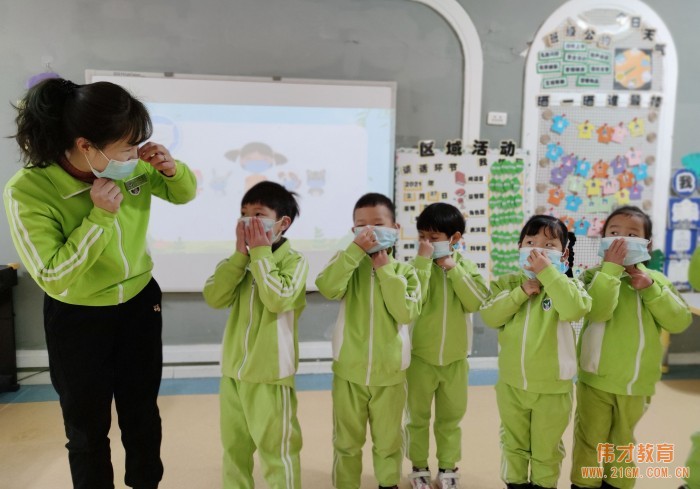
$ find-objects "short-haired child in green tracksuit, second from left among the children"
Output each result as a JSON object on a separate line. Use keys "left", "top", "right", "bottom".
{"left": 316, "top": 193, "right": 421, "bottom": 489}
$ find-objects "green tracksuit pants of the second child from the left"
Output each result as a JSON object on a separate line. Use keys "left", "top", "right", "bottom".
{"left": 332, "top": 375, "right": 406, "bottom": 489}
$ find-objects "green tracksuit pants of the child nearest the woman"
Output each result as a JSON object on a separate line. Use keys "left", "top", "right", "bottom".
{"left": 219, "top": 376, "right": 301, "bottom": 489}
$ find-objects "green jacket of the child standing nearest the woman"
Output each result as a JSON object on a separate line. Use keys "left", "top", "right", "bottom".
{"left": 204, "top": 240, "right": 309, "bottom": 387}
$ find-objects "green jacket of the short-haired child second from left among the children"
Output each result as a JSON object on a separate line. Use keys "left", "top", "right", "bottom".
{"left": 316, "top": 243, "right": 421, "bottom": 386}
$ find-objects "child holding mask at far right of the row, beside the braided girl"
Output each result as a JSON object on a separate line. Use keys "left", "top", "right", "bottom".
{"left": 571, "top": 206, "right": 692, "bottom": 488}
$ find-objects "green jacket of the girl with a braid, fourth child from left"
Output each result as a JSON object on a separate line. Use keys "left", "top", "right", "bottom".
{"left": 481, "top": 265, "right": 591, "bottom": 394}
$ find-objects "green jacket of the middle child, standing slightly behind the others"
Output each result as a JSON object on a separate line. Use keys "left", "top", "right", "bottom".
{"left": 411, "top": 253, "right": 489, "bottom": 366}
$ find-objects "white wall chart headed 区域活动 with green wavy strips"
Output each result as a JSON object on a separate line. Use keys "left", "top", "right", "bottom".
{"left": 395, "top": 140, "right": 528, "bottom": 280}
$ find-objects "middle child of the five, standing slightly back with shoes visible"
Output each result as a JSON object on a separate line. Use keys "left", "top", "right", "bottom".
{"left": 405, "top": 203, "right": 489, "bottom": 489}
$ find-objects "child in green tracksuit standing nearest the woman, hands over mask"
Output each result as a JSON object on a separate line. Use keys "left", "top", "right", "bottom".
{"left": 204, "top": 182, "right": 308, "bottom": 489}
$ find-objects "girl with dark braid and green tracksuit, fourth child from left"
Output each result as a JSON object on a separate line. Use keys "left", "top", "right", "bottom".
{"left": 481, "top": 215, "right": 591, "bottom": 489}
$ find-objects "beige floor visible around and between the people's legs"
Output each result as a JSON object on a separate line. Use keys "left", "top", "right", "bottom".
{"left": 0, "top": 380, "right": 700, "bottom": 489}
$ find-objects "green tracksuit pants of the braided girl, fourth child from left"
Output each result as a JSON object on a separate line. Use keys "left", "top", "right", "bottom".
{"left": 496, "top": 381, "right": 572, "bottom": 488}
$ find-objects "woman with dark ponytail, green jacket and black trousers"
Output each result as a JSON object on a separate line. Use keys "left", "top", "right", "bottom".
{"left": 3, "top": 78, "right": 196, "bottom": 489}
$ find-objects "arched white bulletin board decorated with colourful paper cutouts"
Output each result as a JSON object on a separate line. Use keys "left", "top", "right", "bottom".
{"left": 523, "top": 0, "right": 677, "bottom": 274}
